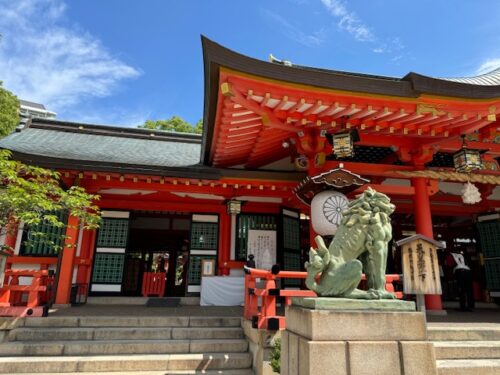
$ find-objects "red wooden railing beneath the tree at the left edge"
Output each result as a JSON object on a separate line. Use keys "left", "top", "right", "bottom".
{"left": 0, "top": 270, "right": 53, "bottom": 317}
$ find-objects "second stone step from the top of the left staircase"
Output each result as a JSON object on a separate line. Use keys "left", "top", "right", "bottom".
{"left": 8, "top": 327, "right": 243, "bottom": 341}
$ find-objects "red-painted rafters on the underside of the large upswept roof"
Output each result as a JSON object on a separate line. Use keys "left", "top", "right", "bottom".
{"left": 211, "top": 74, "right": 500, "bottom": 166}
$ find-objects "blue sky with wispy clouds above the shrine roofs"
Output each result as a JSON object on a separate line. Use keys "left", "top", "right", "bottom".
{"left": 0, "top": 0, "right": 500, "bottom": 126}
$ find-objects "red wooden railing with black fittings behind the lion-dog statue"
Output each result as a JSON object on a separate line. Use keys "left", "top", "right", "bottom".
{"left": 243, "top": 266, "right": 403, "bottom": 330}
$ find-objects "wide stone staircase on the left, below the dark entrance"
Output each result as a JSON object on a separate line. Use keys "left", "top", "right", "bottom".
{"left": 0, "top": 316, "right": 253, "bottom": 375}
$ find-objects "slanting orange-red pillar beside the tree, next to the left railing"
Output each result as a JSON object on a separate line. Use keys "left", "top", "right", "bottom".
{"left": 55, "top": 215, "right": 79, "bottom": 305}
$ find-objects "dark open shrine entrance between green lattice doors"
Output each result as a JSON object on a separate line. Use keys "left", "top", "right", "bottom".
{"left": 122, "top": 212, "right": 190, "bottom": 296}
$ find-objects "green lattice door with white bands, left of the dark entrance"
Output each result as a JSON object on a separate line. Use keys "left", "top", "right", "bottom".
{"left": 90, "top": 211, "right": 129, "bottom": 294}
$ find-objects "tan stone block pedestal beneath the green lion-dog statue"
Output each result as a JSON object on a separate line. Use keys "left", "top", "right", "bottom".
{"left": 281, "top": 298, "right": 437, "bottom": 375}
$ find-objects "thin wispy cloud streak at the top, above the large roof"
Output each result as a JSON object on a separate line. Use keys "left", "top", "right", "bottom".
{"left": 321, "top": 0, "right": 376, "bottom": 42}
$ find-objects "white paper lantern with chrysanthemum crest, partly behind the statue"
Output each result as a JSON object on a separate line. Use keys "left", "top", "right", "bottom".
{"left": 311, "top": 190, "right": 349, "bottom": 236}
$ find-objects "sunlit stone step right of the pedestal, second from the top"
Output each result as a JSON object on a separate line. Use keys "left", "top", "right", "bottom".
{"left": 434, "top": 341, "right": 500, "bottom": 359}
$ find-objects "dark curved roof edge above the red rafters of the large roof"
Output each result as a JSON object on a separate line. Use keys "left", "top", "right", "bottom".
{"left": 202, "top": 36, "right": 500, "bottom": 100}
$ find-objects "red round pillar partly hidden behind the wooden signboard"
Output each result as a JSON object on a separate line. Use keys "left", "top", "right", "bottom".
{"left": 411, "top": 177, "right": 443, "bottom": 310}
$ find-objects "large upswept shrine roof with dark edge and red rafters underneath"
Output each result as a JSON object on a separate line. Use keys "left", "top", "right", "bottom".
{"left": 202, "top": 37, "right": 500, "bottom": 169}
